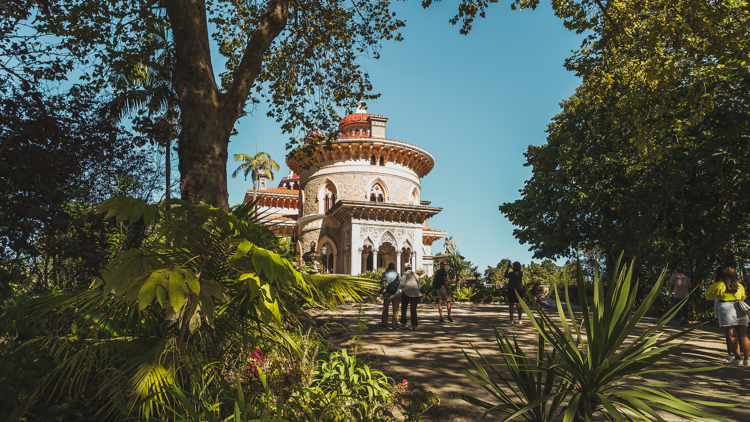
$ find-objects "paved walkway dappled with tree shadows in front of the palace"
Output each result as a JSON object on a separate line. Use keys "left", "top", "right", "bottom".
{"left": 317, "top": 303, "right": 750, "bottom": 422}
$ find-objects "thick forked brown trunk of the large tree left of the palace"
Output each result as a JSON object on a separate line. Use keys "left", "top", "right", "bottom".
{"left": 164, "top": 0, "right": 289, "bottom": 210}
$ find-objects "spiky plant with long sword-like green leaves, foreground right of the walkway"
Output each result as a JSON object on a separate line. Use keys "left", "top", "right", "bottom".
{"left": 458, "top": 260, "right": 737, "bottom": 422}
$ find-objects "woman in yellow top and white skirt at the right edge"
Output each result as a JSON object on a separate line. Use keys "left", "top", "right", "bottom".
{"left": 706, "top": 267, "right": 750, "bottom": 366}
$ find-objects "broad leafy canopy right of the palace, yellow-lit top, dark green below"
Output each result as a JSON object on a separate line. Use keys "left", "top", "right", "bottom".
{"left": 500, "top": 1, "right": 750, "bottom": 277}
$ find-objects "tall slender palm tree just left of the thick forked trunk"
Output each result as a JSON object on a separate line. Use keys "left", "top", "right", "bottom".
{"left": 108, "top": 24, "right": 179, "bottom": 199}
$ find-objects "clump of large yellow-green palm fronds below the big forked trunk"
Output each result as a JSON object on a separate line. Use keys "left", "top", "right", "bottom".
{"left": 9, "top": 197, "right": 376, "bottom": 421}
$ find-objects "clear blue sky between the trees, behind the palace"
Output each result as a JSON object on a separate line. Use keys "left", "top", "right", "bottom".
{"left": 227, "top": 2, "right": 582, "bottom": 271}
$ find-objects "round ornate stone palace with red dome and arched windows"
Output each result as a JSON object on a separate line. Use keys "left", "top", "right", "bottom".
{"left": 245, "top": 109, "right": 445, "bottom": 275}
